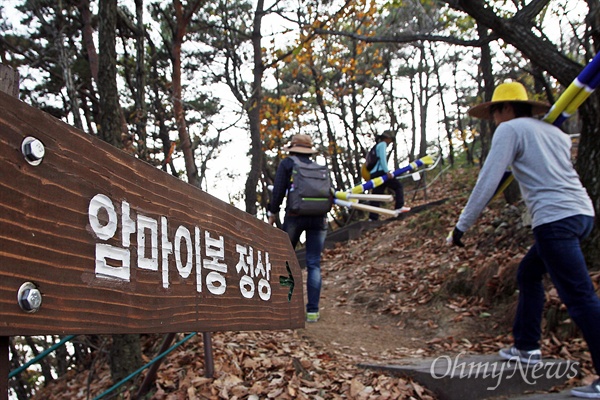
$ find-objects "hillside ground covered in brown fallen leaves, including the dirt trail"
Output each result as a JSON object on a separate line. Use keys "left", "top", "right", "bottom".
{"left": 31, "top": 163, "right": 600, "bottom": 399}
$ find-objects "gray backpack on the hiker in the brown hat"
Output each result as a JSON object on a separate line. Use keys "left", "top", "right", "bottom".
{"left": 287, "top": 156, "right": 333, "bottom": 215}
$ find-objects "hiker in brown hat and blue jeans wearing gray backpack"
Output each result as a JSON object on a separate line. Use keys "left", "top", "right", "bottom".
{"left": 267, "top": 134, "right": 333, "bottom": 322}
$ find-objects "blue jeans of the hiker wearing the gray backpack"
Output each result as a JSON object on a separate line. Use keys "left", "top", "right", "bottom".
{"left": 283, "top": 214, "right": 327, "bottom": 312}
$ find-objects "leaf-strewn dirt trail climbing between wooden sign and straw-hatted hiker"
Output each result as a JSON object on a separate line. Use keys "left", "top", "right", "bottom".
{"left": 298, "top": 211, "right": 504, "bottom": 368}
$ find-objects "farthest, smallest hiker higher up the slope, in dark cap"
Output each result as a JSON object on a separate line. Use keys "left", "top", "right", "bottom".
{"left": 367, "top": 130, "right": 410, "bottom": 221}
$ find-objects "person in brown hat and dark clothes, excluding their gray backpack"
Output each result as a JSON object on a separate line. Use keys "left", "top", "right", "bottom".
{"left": 267, "top": 135, "right": 327, "bottom": 322}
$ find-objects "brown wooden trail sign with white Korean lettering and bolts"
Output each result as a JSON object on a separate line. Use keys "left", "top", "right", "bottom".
{"left": 0, "top": 92, "right": 304, "bottom": 336}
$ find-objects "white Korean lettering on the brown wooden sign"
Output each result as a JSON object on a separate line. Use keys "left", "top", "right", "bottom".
{"left": 88, "top": 194, "right": 271, "bottom": 301}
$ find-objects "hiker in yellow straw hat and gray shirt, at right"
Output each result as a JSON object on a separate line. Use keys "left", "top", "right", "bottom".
{"left": 447, "top": 82, "right": 600, "bottom": 399}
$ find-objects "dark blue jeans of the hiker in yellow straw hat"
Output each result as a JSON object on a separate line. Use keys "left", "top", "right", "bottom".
{"left": 513, "top": 215, "right": 600, "bottom": 372}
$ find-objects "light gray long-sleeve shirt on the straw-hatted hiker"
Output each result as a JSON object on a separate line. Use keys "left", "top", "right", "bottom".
{"left": 456, "top": 118, "right": 594, "bottom": 232}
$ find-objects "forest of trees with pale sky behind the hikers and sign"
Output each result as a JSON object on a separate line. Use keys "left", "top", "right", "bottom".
{"left": 0, "top": 0, "right": 600, "bottom": 396}
